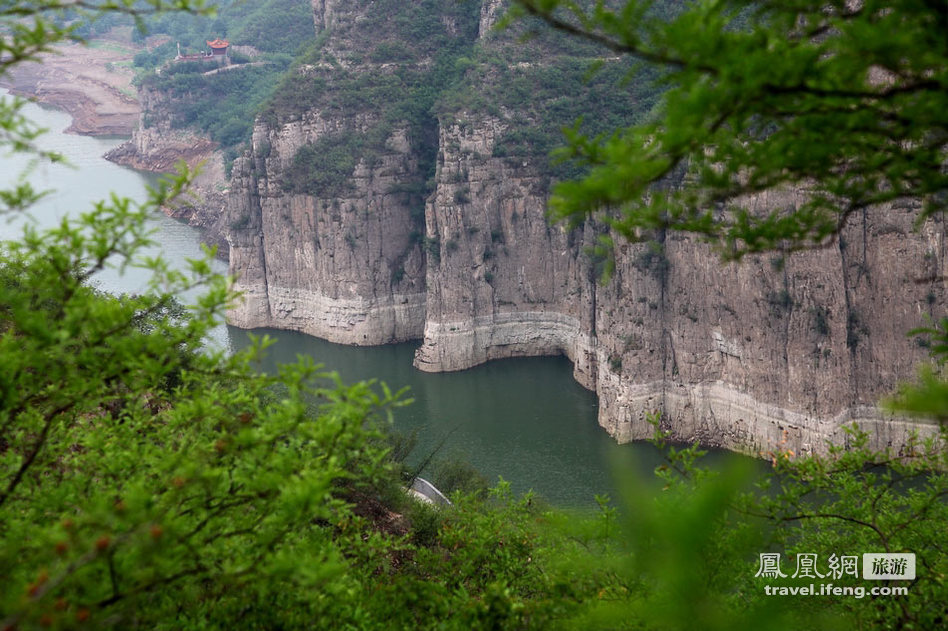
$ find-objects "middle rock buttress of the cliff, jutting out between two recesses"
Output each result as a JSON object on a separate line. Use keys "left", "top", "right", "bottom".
{"left": 415, "top": 116, "right": 595, "bottom": 387}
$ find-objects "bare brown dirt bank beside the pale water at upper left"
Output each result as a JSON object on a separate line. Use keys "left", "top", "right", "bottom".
{"left": 0, "top": 39, "right": 140, "bottom": 136}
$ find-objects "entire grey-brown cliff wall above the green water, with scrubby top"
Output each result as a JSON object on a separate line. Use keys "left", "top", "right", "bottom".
{"left": 226, "top": 0, "right": 948, "bottom": 453}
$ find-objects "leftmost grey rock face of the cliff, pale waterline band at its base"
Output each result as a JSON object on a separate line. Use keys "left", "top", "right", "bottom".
{"left": 228, "top": 117, "right": 425, "bottom": 344}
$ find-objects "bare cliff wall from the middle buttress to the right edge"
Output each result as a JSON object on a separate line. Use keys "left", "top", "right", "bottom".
{"left": 415, "top": 103, "right": 945, "bottom": 453}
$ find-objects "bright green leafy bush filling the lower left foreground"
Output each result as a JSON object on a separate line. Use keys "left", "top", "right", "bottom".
{"left": 0, "top": 175, "right": 382, "bottom": 628}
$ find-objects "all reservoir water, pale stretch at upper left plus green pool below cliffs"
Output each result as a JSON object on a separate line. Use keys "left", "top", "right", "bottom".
{"left": 0, "top": 91, "right": 712, "bottom": 507}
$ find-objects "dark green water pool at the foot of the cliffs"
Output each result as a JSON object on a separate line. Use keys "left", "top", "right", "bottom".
{"left": 228, "top": 334, "right": 672, "bottom": 506}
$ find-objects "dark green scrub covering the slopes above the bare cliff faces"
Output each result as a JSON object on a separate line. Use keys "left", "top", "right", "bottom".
{"left": 263, "top": 2, "right": 660, "bottom": 196}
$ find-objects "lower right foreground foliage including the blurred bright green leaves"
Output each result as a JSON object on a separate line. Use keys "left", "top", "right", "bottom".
{"left": 564, "top": 420, "right": 948, "bottom": 631}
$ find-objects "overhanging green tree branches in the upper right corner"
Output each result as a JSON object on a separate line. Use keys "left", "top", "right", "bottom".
{"left": 512, "top": 0, "right": 948, "bottom": 259}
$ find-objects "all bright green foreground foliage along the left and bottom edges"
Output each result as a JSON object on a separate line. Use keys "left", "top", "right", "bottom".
{"left": 0, "top": 5, "right": 948, "bottom": 631}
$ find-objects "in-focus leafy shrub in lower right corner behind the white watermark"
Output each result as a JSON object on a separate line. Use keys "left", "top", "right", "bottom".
{"left": 745, "top": 431, "right": 948, "bottom": 629}
